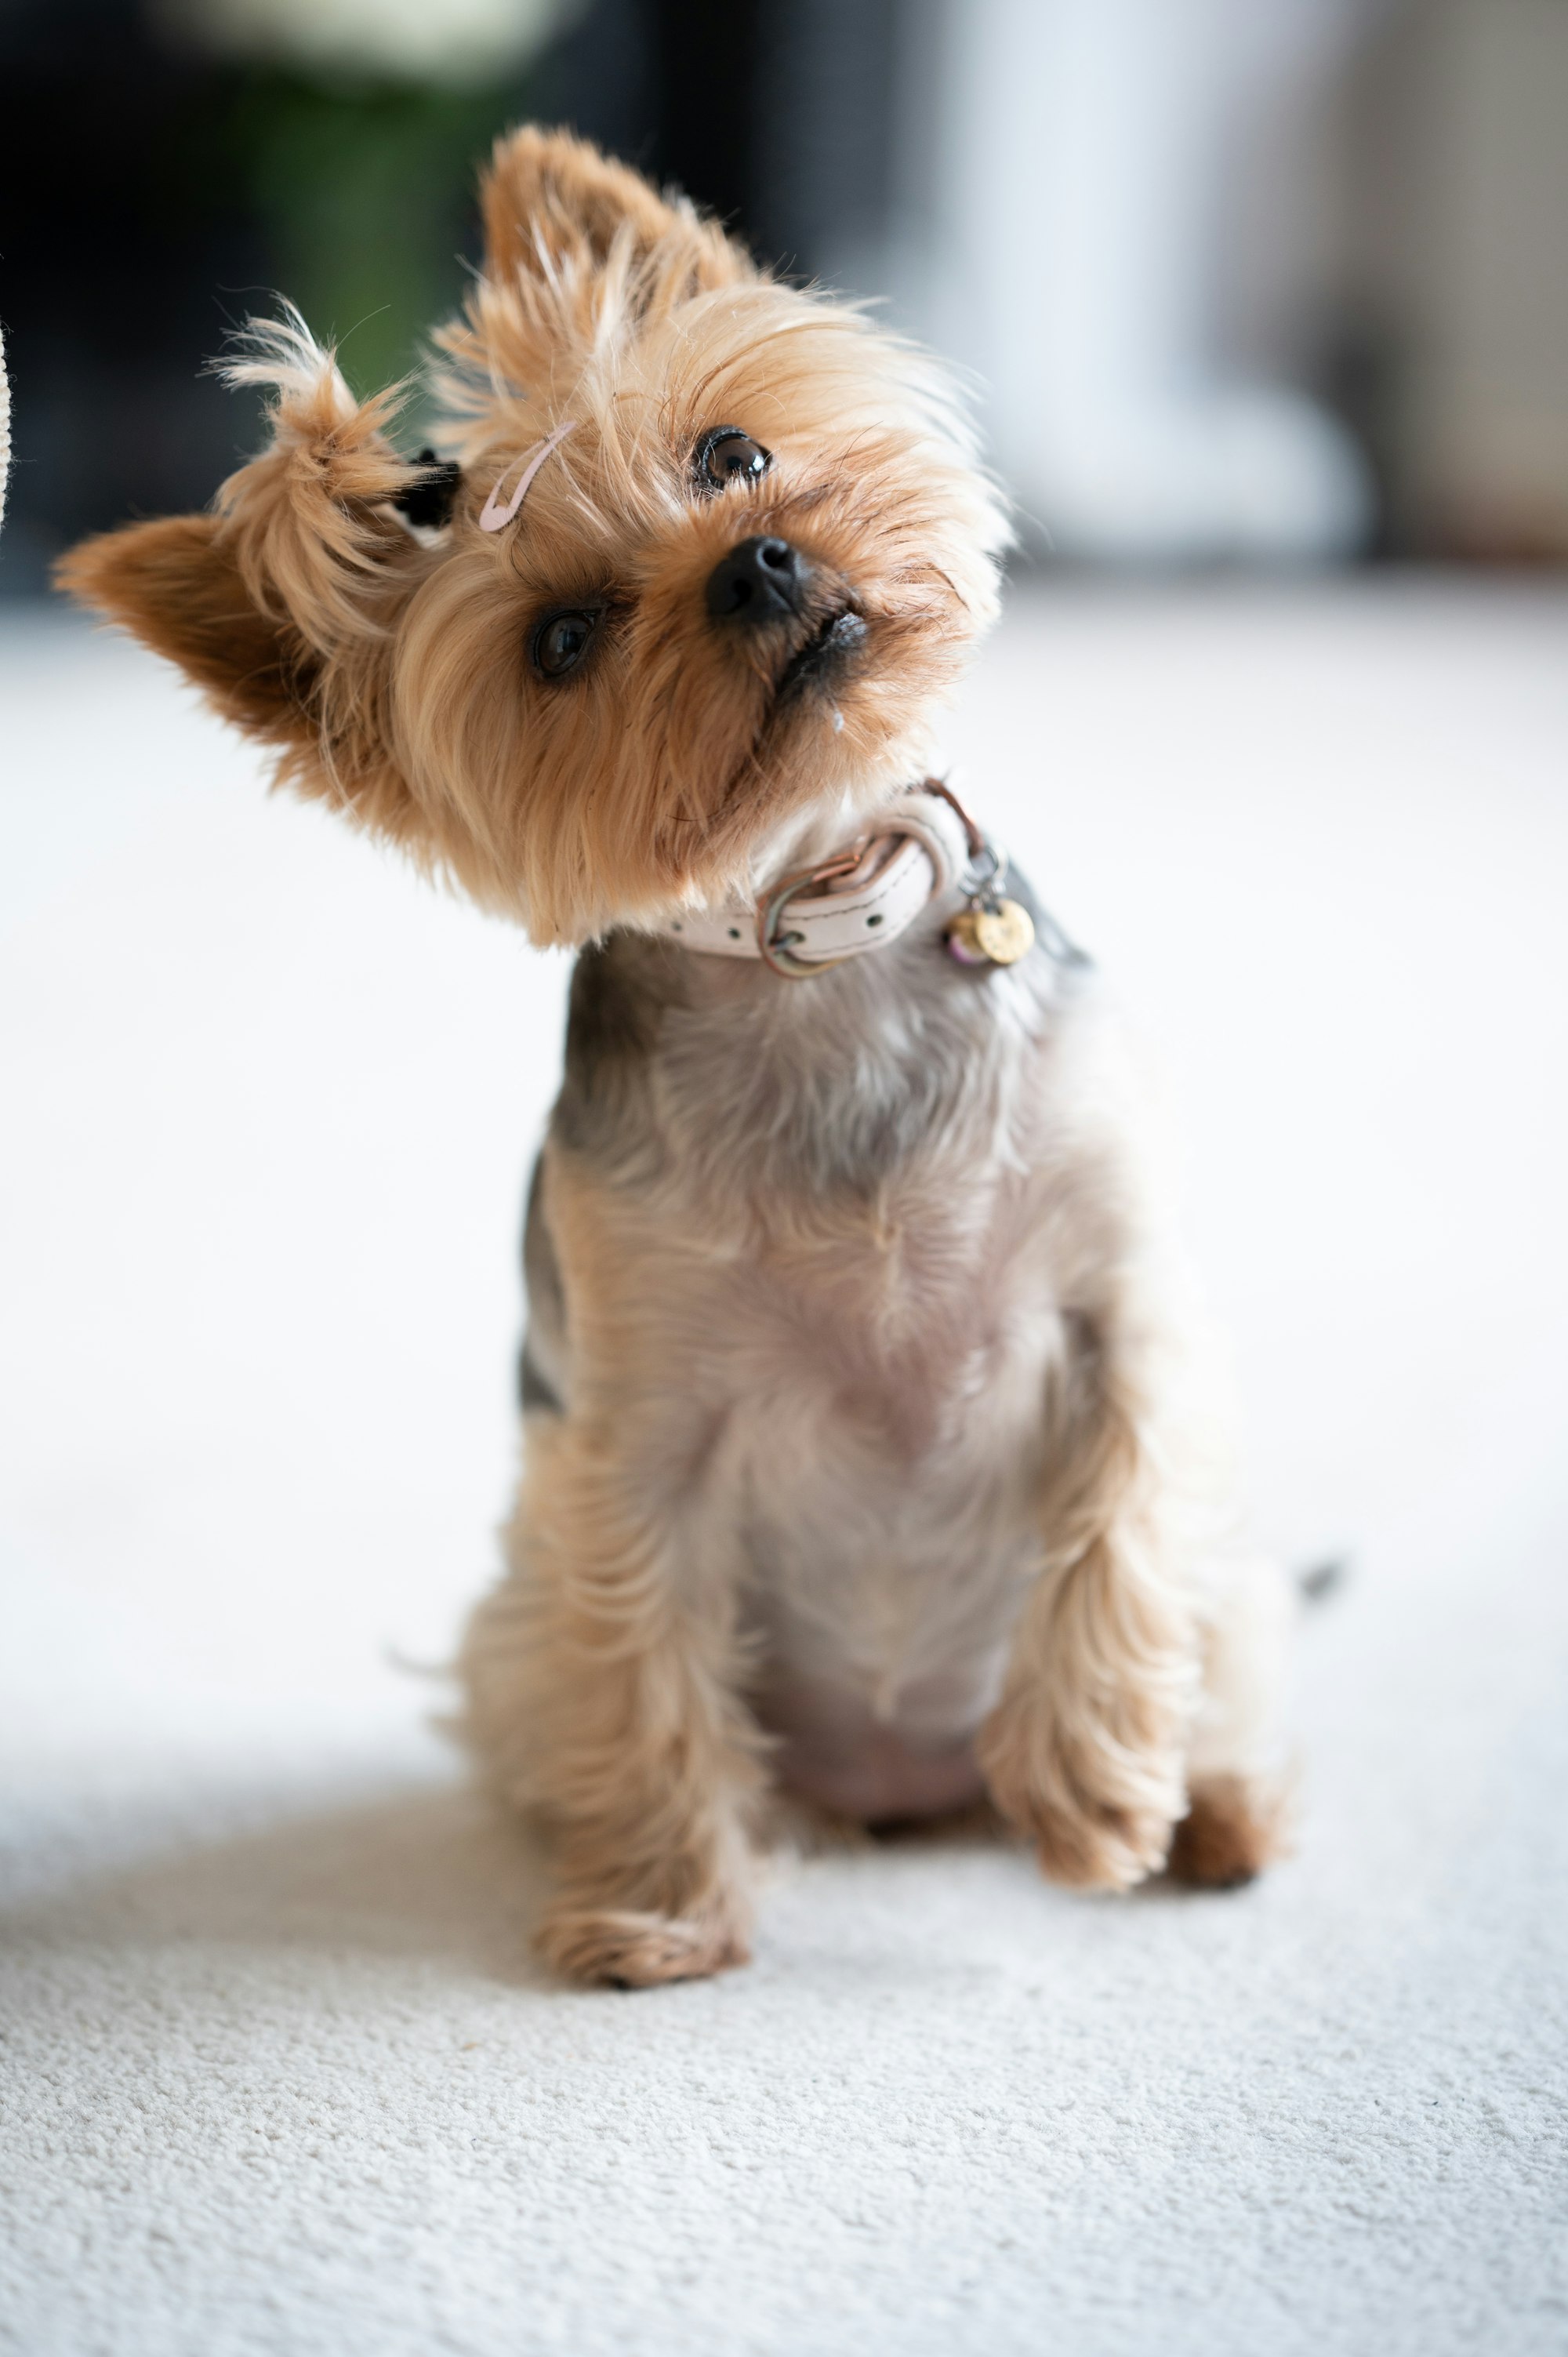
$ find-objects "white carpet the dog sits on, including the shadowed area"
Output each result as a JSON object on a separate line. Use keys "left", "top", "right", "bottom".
{"left": 0, "top": 584, "right": 1568, "bottom": 2357}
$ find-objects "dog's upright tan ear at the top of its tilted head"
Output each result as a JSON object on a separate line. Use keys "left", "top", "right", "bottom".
{"left": 481, "top": 122, "right": 757, "bottom": 290}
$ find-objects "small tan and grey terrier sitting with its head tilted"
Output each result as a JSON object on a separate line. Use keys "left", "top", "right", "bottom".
{"left": 64, "top": 129, "right": 1283, "bottom": 1982}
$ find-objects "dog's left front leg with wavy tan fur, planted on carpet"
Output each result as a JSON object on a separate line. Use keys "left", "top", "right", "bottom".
{"left": 462, "top": 1417, "right": 761, "bottom": 1987}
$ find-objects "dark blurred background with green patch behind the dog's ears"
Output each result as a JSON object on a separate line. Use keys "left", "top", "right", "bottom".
{"left": 0, "top": 0, "right": 894, "bottom": 597}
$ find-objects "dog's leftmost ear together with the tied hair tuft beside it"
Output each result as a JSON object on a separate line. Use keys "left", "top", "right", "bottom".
{"left": 56, "top": 311, "right": 429, "bottom": 832}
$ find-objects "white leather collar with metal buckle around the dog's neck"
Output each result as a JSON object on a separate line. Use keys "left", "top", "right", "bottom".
{"left": 662, "top": 787, "right": 971, "bottom": 978}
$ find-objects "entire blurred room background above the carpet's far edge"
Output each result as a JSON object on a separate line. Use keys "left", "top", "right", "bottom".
{"left": 0, "top": 0, "right": 1568, "bottom": 597}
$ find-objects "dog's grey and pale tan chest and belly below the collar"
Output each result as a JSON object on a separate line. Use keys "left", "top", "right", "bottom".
{"left": 556, "top": 924, "right": 1094, "bottom": 1815}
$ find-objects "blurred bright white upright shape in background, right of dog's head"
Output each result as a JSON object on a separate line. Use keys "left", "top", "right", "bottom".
{"left": 896, "top": 0, "right": 1370, "bottom": 561}
